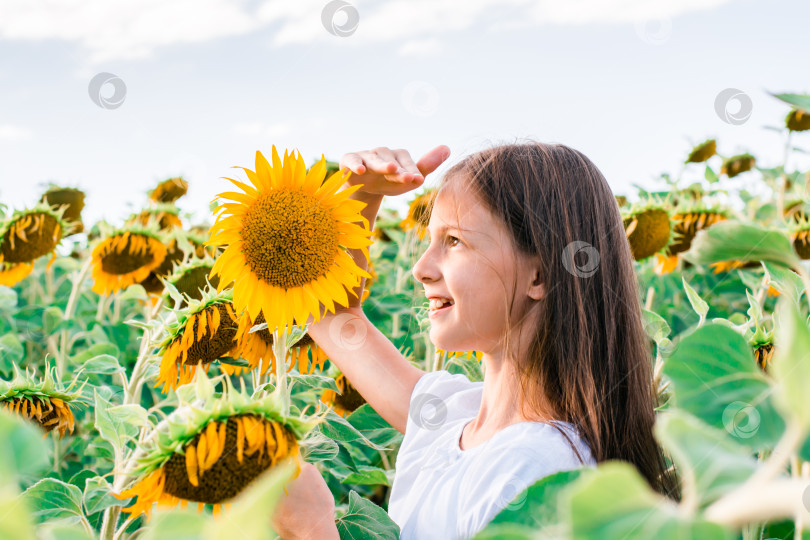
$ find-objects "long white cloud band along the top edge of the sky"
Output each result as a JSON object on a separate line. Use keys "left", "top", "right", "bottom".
{"left": 0, "top": 0, "right": 732, "bottom": 63}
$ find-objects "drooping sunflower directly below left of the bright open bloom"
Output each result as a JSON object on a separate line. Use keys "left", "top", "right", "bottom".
{"left": 155, "top": 290, "right": 242, "bottom": 394}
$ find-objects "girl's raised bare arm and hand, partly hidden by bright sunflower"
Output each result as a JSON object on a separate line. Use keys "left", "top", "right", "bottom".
{"left": 308, "top": 145, "right": 450, "bottom": 433}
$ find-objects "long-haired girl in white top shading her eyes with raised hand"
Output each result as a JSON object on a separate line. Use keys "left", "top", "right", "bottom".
{"left": 273, "top": 142, "right": 676, "bottom": 540}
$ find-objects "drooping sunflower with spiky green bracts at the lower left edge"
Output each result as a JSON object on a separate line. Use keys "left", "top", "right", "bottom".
{"left": 0, "top": 364, "right": 87, "bottom": 439}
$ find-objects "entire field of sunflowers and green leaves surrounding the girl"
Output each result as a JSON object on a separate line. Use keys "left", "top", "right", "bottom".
{"left": 0, "top": 90, "right": 810, "bottom": 540}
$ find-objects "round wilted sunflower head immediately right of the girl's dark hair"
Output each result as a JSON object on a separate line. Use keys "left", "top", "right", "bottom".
{"left": 622, "top": 199, "right": 672, "bottom": 261}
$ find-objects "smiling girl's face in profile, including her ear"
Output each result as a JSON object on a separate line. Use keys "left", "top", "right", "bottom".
{"left": 413, "top": 184, "right": 543, "bottom": 354}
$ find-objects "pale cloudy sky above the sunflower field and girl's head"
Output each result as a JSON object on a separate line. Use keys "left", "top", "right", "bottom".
{"left": 0, "top": 0, "right": 810, "bottom": 228}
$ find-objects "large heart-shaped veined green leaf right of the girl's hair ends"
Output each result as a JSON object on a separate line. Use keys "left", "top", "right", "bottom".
{"left": 663, "top": 323, "right": 785, "bottom": 450}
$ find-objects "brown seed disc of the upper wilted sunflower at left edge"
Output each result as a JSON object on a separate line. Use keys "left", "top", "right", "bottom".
{"left": 0, "top": 213, "right": 61, "bottom": 263}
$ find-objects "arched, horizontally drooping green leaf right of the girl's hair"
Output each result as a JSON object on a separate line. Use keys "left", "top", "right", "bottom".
{"left": 683, "top": 220, "right": 800, "bottom": 268}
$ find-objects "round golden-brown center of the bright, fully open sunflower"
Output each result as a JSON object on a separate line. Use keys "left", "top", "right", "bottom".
{"left": 240, "top": 189, "right": 338, "bottom": 289}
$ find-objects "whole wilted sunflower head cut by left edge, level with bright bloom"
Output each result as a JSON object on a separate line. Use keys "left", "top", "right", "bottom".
{"left": 0, "top": 203, "right": 69, "bottom": 264}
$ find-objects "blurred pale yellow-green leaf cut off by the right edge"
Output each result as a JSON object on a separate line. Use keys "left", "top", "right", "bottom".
{"left": 771, "top": 299, "right": 810, "bottom": 433}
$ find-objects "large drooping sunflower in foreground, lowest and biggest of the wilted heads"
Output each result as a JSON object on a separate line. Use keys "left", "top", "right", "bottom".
{"left": 114, "top": 380, "right": 320, "bottom": 517}
